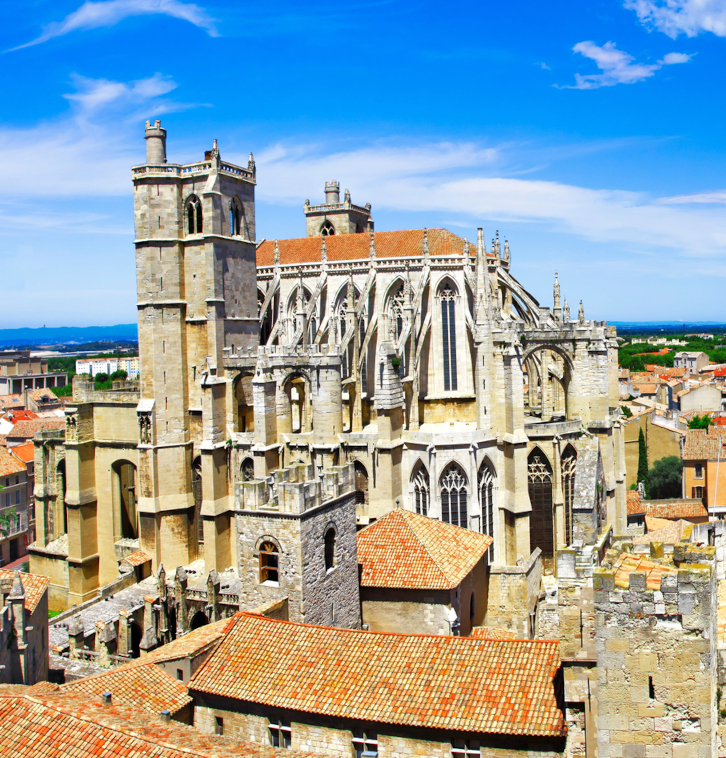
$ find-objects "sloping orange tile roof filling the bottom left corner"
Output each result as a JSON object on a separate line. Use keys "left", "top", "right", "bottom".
{"left": 0, "top": 683, "right": 311, "bottom": 758}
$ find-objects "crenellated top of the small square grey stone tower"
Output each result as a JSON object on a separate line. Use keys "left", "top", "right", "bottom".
{"left": 235, "top": 463, "right": 355, "bottom": 515}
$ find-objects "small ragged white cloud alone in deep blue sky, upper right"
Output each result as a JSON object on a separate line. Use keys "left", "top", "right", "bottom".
{"left": 555, "top": 41, "right": 693, "bottom": 89}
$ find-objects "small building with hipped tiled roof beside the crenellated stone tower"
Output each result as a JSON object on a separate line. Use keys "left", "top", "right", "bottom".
{"left": 358, "top": 509, "right": 492, "bottom": 636}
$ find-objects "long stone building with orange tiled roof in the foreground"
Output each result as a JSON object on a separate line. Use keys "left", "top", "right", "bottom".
{"left": 189, "top": 613, "right": 567, "bottom": 758}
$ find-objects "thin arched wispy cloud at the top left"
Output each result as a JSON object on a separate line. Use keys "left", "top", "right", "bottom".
{"left": 9, "top": 0, "right": 217, "bottom": 52}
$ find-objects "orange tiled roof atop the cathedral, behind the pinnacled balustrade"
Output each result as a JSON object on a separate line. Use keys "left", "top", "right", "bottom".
{"left": 257, "top": 229, "right": 476, "bottom": 268}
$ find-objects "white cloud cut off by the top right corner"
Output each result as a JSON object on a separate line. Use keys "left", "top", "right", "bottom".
{"left": 624, "top": 0, "right": 726, "bottom": 39}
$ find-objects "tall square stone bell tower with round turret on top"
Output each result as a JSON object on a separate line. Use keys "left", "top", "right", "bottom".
{"left": 133, "top": 121, "right": 258, "bottom": 569}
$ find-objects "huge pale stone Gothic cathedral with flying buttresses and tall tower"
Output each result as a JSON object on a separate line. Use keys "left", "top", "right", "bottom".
{"left": 30, "top": 121, "right": 626, "bottom": 620}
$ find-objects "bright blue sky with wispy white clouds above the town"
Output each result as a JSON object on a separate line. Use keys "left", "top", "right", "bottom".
{"left": 0, "top": 0, "right": 726, "bottom": 328}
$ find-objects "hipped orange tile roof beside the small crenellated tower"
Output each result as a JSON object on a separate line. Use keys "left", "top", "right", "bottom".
{"left": 358, "top": 509, "right": 493, "bottom": 590}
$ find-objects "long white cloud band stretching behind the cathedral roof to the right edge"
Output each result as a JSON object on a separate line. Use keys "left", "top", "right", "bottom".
{"left": 252, "top": 143, "right": 726, "bottom": 259}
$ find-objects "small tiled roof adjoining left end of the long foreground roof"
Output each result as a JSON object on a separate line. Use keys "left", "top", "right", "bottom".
{"left": 63, "top": 657, "right": 192, "bottom": 713}
